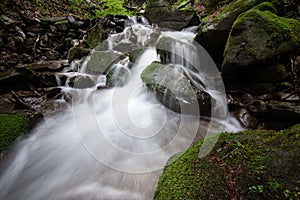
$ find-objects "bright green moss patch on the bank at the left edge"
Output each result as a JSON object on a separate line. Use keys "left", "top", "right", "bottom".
{"left": 0, "top": 114, "right": 28, "bottom": 152}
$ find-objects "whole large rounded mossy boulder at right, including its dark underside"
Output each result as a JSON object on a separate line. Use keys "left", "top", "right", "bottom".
{"left": 222, "top": 8, "right": 300, "bottom": 82}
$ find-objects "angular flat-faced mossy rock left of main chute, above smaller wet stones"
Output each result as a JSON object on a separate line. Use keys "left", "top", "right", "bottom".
{"left": 86, "top": 51, "right": 124, "bottom": 75}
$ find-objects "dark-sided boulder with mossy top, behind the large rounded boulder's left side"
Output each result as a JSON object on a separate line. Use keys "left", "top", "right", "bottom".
{"left": 195, "top": 0, "right": 284, "bottom": 66}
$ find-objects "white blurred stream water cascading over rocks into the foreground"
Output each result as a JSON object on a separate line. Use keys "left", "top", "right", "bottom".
{"left": 0, "top": 16, "right": 240, "bottom": 200}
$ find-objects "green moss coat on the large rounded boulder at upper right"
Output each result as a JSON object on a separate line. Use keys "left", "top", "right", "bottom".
{"left": 223, "top": 6, "right": 300, "bottom": 72}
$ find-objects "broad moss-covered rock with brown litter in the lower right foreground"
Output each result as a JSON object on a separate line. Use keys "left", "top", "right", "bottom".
{"left": 154, "top": 125, "right": 300, "bottom": 200}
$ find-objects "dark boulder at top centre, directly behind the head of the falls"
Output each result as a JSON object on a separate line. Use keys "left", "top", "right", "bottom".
{"left": 145, "top": 0, "right": 200, "bottom": 30}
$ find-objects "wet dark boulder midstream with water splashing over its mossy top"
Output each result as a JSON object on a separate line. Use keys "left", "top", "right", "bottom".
{"left": 141, "top": 62, "right": 211, "bottom": 116}
